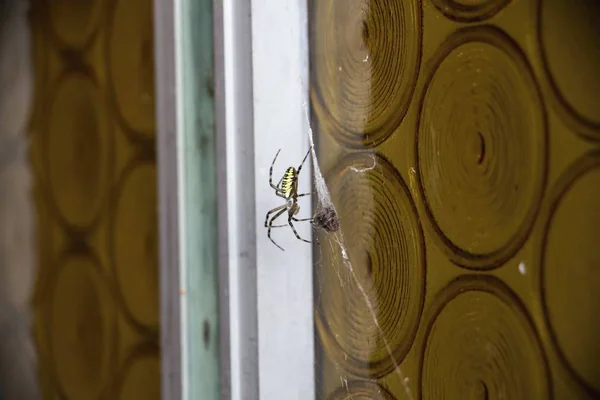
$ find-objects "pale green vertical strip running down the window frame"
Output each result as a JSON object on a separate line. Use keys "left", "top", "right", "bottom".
{"left": 177, "top": 0, "right": 220, "bottom": 400}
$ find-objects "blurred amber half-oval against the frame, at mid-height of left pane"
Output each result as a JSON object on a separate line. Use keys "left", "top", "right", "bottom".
{"left": 112, "top": 162, "right": 159, "bottom": 329}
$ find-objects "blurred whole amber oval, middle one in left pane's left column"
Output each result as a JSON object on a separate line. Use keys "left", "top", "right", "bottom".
{"left": 43, "top": 72, "right": 111, "bottom": 229}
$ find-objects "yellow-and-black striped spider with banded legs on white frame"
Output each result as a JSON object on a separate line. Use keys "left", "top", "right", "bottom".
{"left": 265, "top": 149, "right": 313, "bottom": 251}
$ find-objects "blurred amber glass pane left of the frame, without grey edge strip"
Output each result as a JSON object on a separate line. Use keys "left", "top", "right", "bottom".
{"left": 30, "top": 0, "right": 161, "bottom": 399}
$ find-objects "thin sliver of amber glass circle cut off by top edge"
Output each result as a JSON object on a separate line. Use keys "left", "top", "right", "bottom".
{"left": 431, "top": 0, "right": 510, "bottom": 22}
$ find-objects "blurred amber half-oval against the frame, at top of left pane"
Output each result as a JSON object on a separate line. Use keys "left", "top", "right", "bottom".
{"left": 108, "top": 0, "right": 155, "bottom": 135}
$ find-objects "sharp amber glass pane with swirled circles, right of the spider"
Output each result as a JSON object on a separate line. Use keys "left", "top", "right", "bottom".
{"left": 309, "top": 0, "right": 600, "bottom": 399}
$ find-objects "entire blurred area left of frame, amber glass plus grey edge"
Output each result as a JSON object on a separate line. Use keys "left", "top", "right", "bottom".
{"left": 0, "top": 0, "right": 160, "bottom": 399}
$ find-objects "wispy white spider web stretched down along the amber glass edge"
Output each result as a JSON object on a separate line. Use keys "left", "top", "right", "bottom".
{"left": 288, "top": 0, "right": 413, "bottom": 400}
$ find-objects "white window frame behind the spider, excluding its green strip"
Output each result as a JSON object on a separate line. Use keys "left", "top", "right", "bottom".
{"left": 154, "top": 0, "right": 315, "bottom": 400}
